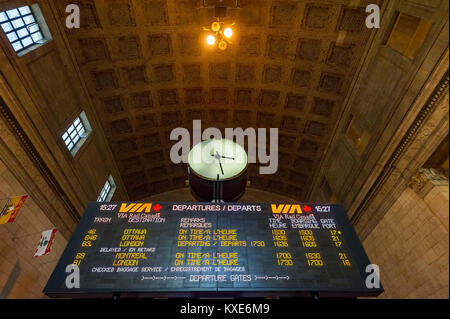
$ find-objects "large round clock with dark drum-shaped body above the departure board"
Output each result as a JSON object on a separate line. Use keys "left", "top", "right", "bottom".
{"left": 188, "top": 139, "right": 248, "bottom": 202}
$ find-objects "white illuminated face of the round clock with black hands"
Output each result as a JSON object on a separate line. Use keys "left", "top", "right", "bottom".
{"left": 189, "top": 139, "right": 248, "bottom": 181}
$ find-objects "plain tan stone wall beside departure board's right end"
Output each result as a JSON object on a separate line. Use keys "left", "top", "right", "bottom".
{"left": 363, "top": 172, "right": 449, "bottom": 299}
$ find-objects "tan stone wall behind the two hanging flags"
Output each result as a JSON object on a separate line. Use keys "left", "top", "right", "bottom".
{"left": 0, "top": 160, "right": 67, "bottom": 299}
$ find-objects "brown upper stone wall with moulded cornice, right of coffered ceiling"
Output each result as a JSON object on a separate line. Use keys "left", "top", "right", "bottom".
{"left": 307, "top": 0, "right": 449, "bottom": 240}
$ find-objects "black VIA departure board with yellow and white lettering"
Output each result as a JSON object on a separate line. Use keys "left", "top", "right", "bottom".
{"left": 44, "top": 202, "right": 383, "bottom": 297}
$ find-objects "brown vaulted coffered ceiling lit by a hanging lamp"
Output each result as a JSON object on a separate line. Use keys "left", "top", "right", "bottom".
{"left": 56, "top": 0, "right": 380, "bottom": 200}
